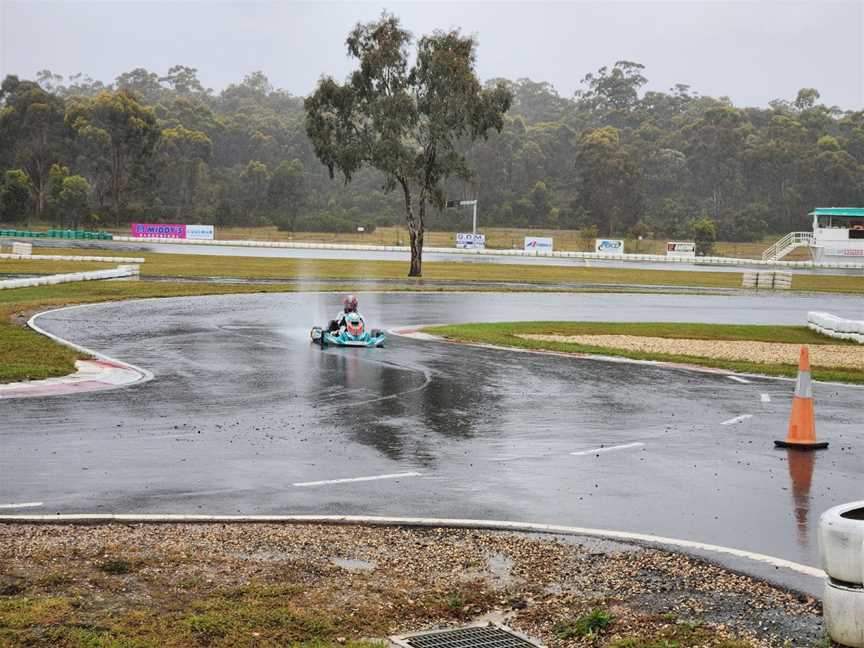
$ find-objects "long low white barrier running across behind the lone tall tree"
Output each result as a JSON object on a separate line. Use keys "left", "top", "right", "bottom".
{"left": 114, "top": 236, "right": 864, "bottom": 273}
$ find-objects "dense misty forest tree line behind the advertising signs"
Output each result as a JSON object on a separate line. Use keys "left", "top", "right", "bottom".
{"left": 0, "top": 56, "right": 864, "bottom": 241}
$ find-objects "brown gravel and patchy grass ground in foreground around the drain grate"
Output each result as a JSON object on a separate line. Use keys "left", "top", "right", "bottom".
{"left": 0, "top": 524, "right": 823, "bottom": 648}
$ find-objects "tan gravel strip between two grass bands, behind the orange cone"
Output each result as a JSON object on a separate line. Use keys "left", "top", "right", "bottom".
{"left": 517, "top": 334, "right": 864, "bottom": 369}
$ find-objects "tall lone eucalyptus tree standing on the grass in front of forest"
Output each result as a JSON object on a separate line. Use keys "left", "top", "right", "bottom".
{"left": 305, "top": 14, "right": 512, "bottom": 277}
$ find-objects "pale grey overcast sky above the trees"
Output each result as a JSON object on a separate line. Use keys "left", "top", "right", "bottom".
{"left": 0, "top": 0, "right": 864, "bottom": 109}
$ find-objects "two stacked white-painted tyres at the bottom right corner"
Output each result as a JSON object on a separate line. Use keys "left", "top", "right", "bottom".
{"left": 818, "top": 501, "right": 864, "bottom": 648}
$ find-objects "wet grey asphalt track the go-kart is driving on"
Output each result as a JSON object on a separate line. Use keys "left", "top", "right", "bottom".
{"left": 0, "top": 293, "right": 864, "bottom": 565}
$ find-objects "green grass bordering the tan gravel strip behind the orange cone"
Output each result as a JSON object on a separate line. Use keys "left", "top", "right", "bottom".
{"left": 424, "top": 322, "right": 864, "bottom": 384}
